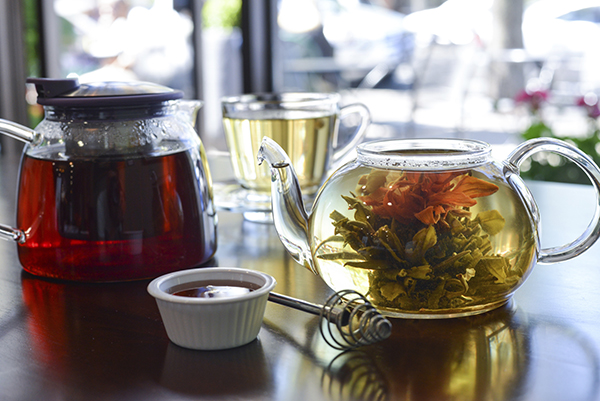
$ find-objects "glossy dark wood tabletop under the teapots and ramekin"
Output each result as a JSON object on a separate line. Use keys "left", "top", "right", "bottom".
{"left": 0, "top": 150, "right": 600, "bottom": 401}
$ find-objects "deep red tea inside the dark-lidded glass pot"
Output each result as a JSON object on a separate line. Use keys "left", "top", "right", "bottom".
{"left": 17, "top": 145, "right": 216, "bottom": 281}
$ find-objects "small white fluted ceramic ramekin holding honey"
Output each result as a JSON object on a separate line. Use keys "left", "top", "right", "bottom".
{"left": 148, "top": 267, "right": 276, "bottom": 350}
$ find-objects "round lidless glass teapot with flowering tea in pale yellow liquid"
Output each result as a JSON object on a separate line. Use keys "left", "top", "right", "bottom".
{"left": 258, "top": 138, "right": 600, "bottom": 318}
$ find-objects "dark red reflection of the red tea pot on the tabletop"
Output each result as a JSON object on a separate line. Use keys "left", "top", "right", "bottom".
{"left": 21, "top": 272, "right": 168, "bottom": 392}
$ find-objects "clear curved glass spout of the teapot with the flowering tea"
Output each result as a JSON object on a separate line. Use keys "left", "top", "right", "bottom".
{"left": 258, "top": 137, "right": 318, "bottom": 274}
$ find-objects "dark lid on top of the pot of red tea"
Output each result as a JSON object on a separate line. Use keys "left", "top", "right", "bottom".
{"left": 27, "top": 78, "right": 183, "bottom": 107}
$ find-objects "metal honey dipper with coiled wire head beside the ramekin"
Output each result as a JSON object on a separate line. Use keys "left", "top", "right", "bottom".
{"left": 269, "top": 290, "right": 392, "bottom": 350}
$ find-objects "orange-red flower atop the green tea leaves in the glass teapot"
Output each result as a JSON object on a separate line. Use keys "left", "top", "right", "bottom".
{"left": 360, "top": 172, "right": 498, "bottom": 225}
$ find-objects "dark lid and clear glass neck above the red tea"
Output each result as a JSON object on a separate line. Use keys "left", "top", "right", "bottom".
{"left": 27, "top": 78, "right": 187, "bottom": 157}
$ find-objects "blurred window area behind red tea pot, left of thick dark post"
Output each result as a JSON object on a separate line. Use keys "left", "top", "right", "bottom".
{"left": 0, "top": 0, "right": 243, "bottom": 148}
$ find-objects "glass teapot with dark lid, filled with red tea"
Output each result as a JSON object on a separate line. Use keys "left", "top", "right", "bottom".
{"left": 0, "top": 78, "right": 216, "bottom": 281}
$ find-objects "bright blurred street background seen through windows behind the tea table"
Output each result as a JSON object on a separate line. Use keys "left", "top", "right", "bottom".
{"left": 0, "top": 0, "right": 600, "bottom": 182}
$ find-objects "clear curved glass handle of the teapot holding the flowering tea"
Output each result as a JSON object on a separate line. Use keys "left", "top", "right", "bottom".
{"left": 504, "top": 138, "right": 600, "bottom": 263}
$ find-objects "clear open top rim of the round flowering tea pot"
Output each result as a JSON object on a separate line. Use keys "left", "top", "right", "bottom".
{"left": 356, "top": 138, "right": 492, "bottom": 171}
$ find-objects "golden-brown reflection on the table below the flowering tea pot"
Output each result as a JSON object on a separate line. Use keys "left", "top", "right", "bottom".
{"left": 322, "top": 304, "right": 531, "bottom": 401}
